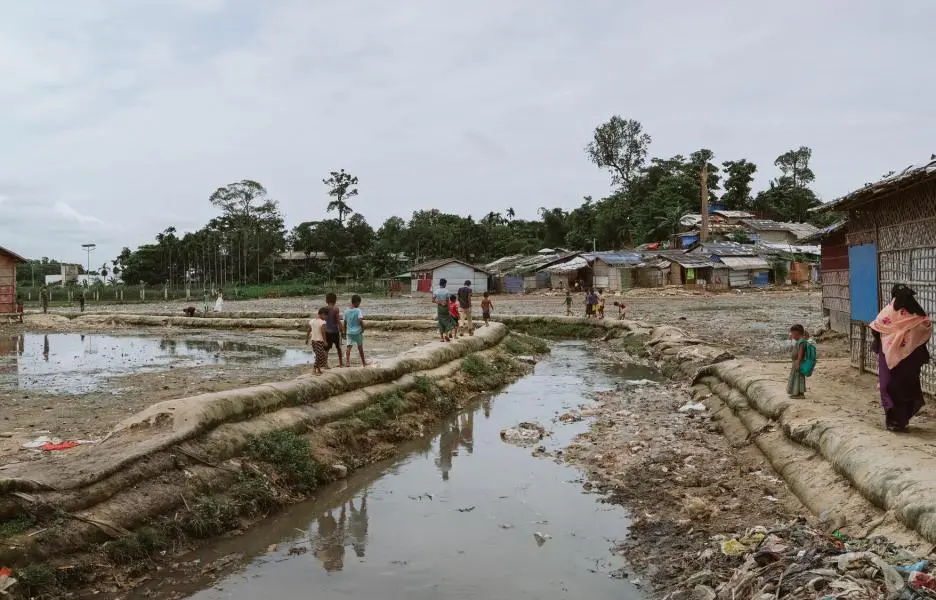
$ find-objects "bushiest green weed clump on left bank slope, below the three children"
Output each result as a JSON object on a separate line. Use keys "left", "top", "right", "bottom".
{"left": 247, "top": 430, "right": 325, "bottom": 493}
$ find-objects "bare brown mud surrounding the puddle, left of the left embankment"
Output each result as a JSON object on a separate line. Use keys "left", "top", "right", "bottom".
{"left": 0, "top": 329, "right": 435, "bottom": 465}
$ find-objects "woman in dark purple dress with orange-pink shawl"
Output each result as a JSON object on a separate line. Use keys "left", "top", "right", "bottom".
{"left": 871, "top": 284, "right": 933, "bottom": 432}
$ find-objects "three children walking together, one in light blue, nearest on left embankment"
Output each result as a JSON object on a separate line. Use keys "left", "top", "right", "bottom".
{"left": 306, "top": 293, "right": 367, "bottom": 375}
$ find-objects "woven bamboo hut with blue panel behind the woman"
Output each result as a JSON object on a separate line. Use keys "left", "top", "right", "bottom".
{"left": 820, "top": 158, "right": 936, "bottom": 393}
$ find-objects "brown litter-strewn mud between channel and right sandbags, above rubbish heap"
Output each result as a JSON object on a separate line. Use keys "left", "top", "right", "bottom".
{"left": 565, "top": 344, "right": 807, "bottom": 596}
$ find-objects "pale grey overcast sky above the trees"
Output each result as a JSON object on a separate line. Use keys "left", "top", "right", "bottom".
{"left": 0, "top": 0, "right": 936, "bottom": 264}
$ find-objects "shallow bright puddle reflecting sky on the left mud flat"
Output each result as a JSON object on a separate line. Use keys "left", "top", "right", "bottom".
{"left": 0, "top": 333, "right": 312, "bottom": 394}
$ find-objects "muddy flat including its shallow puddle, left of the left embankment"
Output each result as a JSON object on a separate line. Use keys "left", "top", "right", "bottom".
{"left": 0, "top": 324, "right": 434, "bottom": 465}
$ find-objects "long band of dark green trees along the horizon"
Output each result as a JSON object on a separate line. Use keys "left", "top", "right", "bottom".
{"left": 111, "top": 116, "right": 824, "bottom": 287}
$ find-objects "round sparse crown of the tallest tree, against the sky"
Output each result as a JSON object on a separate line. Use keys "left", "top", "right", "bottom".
{"left": 585, "top": 115, "right": 652, "bottom": 190}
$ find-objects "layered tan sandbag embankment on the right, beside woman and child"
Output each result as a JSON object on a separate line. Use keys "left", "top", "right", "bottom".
{"left": 632, "top": 326, "right": 936, "bottom": 544}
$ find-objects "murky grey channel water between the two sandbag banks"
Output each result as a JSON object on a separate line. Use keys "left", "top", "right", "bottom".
{"left": 131, "top": 343, "right": 653, "bottom": 600}
